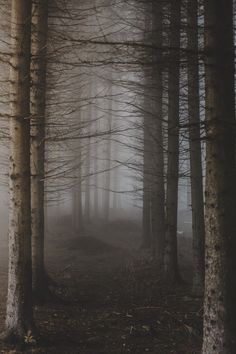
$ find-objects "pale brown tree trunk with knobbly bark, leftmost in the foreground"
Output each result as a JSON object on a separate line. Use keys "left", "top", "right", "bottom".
{"left": 6, "top": 0, "right": 33, "bottom": 341}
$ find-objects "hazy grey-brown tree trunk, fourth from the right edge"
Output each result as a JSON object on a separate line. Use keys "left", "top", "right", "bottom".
{"left": 151, "top": 0, "right": 165, "bottom": 267}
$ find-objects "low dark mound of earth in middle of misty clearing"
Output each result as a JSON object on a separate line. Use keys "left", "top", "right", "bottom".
{"left": 65, "top": 236, "right": 118, "bottom": 255}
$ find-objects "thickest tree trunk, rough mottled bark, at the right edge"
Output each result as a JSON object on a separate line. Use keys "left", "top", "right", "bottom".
{"left": 202, "top": 0, "right": 236, "bottom": 354}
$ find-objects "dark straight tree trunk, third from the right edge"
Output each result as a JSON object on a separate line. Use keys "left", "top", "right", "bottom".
{"left": 165, "top": 0, "right": 181, "bottom": 281}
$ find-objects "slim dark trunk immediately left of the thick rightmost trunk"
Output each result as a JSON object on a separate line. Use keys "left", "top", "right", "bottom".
{"left": 187, "top": 0, "right": 205, "bottom": 295}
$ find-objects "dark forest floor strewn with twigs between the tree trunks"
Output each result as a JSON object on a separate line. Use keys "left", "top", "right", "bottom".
{"left": 0, "top": 220, "right": 202, "bottom": 354}
